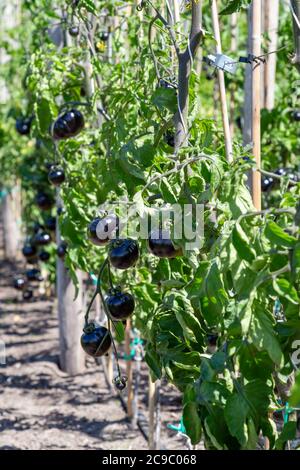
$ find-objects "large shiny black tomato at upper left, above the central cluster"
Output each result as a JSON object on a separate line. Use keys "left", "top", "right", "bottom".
{"left": 53, "top": 109, "right": 84, "bottom": 140}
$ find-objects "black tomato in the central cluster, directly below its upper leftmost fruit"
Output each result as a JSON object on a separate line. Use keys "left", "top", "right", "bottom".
{"left": 108, "top": 238, "right": 139, "bottom": 269}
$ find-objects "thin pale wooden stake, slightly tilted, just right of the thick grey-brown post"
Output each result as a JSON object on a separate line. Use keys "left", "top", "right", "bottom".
{"left": 212, "top": 0, "right": 232, "bottom": 162}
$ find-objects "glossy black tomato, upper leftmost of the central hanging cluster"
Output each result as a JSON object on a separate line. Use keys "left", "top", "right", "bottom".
{"left": 88, "top": 214, "right": 119, "bottom": 246}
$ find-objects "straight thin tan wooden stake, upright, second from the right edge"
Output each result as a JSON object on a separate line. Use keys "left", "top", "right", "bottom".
{"left": 252, "top": 0, "right": 261, "bottom": 211}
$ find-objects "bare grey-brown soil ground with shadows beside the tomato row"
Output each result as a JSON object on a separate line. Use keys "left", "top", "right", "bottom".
{"left": 0, "top": 232, "right": 187, "bottom": 450}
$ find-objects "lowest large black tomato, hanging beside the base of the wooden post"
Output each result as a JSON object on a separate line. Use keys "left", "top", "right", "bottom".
{"left": 80, "top": 323, "right": 111, "bottom": 357}
